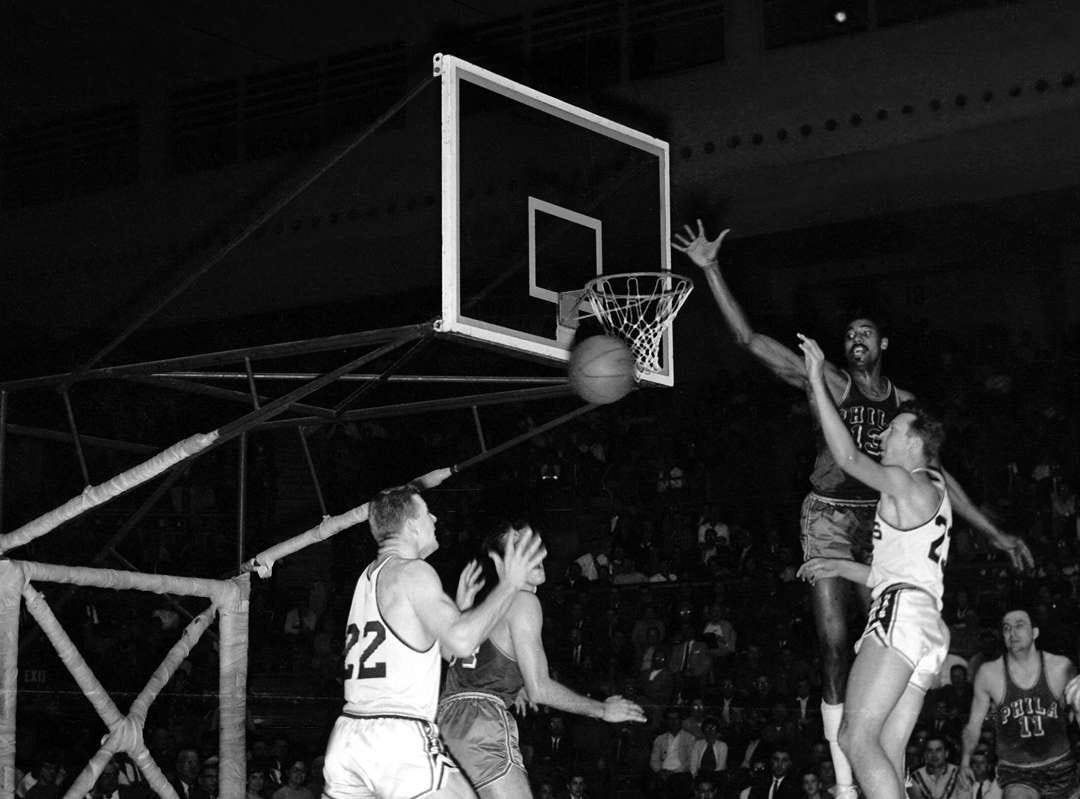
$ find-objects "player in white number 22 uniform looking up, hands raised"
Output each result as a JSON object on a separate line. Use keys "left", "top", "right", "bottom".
{"left": 323, "top": 485, "right": 546, "bottom": 799}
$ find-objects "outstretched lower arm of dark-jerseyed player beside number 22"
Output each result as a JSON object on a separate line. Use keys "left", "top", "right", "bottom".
{"left": 507, "top": 592, "right": 645, "bottom": 723}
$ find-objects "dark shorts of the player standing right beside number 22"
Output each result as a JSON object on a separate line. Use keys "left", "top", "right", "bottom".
{"left": 437, "top": 691, "right": 525, "bottom": 788}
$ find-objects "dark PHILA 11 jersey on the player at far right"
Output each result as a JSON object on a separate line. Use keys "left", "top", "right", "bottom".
{"left": 995, "top": 652, "right": 1070, "bottom": 766}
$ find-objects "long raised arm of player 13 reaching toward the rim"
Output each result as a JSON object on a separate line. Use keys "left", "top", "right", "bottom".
{"left": 672, "top": 219, "right": 845, "bottom": 396}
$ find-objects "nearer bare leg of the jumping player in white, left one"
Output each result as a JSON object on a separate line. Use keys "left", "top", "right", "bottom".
{"left": 840, "top": 636, "right": 912, "bottom": 799}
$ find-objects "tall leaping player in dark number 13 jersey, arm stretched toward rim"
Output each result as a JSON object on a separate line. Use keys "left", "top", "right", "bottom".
{"left": 672, "top": 219, "right": 1034, "bottom": 799}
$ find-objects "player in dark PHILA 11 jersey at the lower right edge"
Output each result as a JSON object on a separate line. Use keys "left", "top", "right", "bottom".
{"left": 960, "top": 609, "right": 1080, "bottom": 799}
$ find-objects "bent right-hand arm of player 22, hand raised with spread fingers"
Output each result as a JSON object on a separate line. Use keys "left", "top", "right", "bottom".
{"left": 412, "top": 533, "right": 546, "bottom": 658}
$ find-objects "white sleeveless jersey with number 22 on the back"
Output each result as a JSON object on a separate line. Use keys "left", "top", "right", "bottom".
{"left": 342, "top": 558, "right": 442, "bottom": 721}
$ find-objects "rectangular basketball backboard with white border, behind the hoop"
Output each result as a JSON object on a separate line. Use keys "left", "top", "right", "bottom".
{"left": 435, "top": 55, "right": 674, "bottom": 385}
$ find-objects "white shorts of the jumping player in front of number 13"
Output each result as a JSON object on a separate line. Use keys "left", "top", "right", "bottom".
{"left": 855, "top": 585, "right": 949, "bottom": 692}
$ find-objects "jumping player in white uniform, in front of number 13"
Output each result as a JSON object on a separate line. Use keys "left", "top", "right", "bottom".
{"left": 799, "top": 335, "right": 953, "bottom": 799}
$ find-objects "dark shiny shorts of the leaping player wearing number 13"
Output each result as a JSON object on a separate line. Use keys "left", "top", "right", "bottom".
{"left": 799, "top": 492, "right": 877, "bottom": 564}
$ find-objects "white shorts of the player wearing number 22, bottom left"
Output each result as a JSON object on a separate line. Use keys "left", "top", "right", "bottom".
{"left": 323, "top": 716, "right": 458, "bottom": 799}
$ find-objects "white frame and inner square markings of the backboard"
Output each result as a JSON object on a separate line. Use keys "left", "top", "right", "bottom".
{"left": 433, "top": 53, "right": 675, "bottom": 385}
